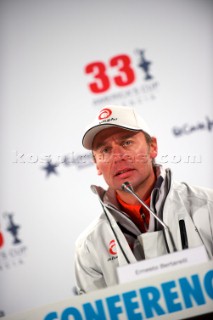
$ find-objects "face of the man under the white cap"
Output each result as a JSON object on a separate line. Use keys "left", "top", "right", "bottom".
{"left": 93, "top": 127, "right": 157, "bottom": 190}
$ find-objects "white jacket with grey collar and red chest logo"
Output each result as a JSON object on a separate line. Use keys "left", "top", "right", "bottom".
{"left": 75, "top": 166, "right": 213, "bottom": 294}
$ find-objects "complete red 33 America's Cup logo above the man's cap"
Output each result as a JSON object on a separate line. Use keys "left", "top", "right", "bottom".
{"left": 84, "top": 49, "right": 159, "bottom": 107}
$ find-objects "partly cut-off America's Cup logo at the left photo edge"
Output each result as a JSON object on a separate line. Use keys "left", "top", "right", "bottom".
{"left": 0, "top": 212, "right": 27, "bottom": 271}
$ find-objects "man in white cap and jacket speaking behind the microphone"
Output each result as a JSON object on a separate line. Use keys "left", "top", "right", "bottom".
{"left": 75, "top": 106, "right": 213, "bottom": 293}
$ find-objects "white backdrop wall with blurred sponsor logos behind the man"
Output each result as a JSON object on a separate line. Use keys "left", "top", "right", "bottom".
{"left": 0, "top": 0, "right": 213, "bottom": 315}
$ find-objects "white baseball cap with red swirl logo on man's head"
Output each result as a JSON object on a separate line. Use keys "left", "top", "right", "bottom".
{"left": 82, "top": 105, "right": 152, "bottom": 150}
